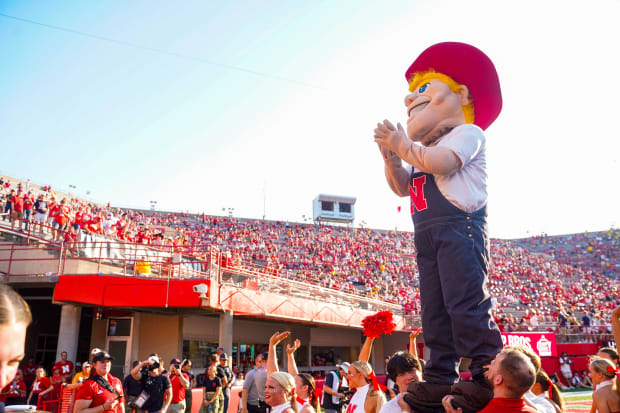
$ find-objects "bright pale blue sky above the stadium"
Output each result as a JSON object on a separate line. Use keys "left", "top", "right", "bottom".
{"left": 0, "top": 0, "right": 620, "bottom": 237}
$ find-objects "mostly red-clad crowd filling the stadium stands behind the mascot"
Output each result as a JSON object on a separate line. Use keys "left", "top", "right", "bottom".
{"left": 0, "top": 175, "right": 620, "bottom": 340}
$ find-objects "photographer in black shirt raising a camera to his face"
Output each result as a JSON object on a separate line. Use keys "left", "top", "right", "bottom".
{"left": 131, "top": 354, "right": 172, "bottom": 413}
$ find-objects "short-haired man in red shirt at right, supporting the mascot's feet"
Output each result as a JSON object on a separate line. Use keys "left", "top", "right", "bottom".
{"left": 442, "top": 348, "right": 537, "bottom": 413}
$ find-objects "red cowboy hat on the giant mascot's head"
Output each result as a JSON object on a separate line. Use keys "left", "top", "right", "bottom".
{"left": 405, "top": 42, "right": 502, "bottom": 129}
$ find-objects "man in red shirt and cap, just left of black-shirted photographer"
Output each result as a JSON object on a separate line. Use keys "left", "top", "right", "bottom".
{"left": 75, "top": 351, "right": 125, "bottom": 413}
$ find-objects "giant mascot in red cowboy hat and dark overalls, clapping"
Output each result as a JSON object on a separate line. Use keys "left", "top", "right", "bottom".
{"left": 374, "top": 42, "right": 502, "bottom": 412}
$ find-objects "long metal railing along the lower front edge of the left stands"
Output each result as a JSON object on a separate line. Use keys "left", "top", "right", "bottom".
{"left": 0, "top": 220, "right": 419, "bottom": 326}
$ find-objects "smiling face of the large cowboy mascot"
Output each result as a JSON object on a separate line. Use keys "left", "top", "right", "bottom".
{"left": 405, "top": 79, "right": 468, "bottom": 146}
